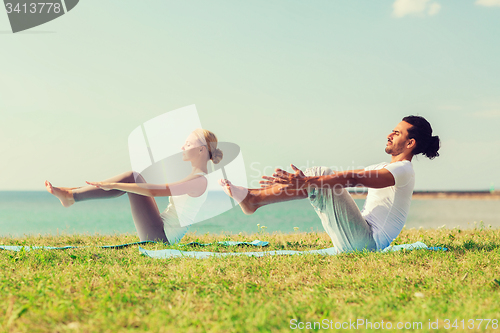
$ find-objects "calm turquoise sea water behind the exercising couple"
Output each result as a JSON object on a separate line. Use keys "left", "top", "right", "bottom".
{"left": 0, "top": 191, "right": 500, "bottom": 237}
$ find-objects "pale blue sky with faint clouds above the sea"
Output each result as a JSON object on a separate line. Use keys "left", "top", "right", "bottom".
{"left": 0, "top": 0, "right": 500, "bottom": 190}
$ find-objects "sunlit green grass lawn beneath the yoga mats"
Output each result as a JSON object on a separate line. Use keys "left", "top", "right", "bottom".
{"left": 0, "top": 229, "right": 500, "bottom": 332}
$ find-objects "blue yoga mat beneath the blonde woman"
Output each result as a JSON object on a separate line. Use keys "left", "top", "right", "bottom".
{"left": 0, "top": 239, "right": 269, "bottom": 251}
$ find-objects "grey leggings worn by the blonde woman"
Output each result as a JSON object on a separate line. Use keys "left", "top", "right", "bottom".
{"left": 72, "top": 171, "right": 168, "bottom": 243}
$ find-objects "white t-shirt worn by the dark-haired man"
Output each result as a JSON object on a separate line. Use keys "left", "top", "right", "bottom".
{"left": 361, "top": 160, "right": 415, "bottom": 249}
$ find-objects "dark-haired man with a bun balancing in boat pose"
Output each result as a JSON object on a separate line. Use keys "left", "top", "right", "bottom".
{"left": 220, "top": 116, "right": 440, "bottom": 253}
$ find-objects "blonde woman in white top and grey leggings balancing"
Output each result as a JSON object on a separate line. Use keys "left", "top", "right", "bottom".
{"left": 45, "top": 129, "right": 223, "bottom": 244}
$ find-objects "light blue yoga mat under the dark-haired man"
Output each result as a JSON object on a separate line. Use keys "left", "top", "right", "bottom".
{"left": 139, "top": 242, "right": 448, "bottom": 259}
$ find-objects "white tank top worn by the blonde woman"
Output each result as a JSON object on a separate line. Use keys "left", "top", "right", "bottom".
{"left": 160, "top": 172, "right": 208, "bottom": 227}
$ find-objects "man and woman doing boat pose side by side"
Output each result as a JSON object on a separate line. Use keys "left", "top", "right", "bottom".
{"left": 45, "top": 116, "right": 440, "bottom": 253}
